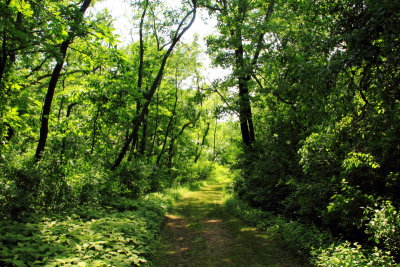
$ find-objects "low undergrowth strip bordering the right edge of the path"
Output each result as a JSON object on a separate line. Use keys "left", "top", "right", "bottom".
{"left": 225, "top": 195, "right": 400, "bottom": 267}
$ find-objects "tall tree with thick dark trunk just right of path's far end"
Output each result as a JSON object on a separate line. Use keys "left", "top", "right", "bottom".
{"left": 204, "top": 0, "right": 275, "bottom": 146}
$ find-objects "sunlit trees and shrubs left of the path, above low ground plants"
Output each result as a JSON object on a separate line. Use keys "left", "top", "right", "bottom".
{"left": 0, "top": 0, "right": 217, "bottom": 219}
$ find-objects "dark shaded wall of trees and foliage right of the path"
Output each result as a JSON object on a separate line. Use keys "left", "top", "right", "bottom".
{"left": 205, "top": 0, "right": 400, "bottom": 266}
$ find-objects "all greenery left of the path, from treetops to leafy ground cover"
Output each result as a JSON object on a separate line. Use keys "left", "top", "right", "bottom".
{"left": 0, "top": 0, "right": 218, "bottom": 266}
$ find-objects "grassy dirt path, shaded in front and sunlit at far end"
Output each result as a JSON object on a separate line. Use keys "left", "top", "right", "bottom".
{"left": 151, "top": 169, "right": 305, "bottom": 267}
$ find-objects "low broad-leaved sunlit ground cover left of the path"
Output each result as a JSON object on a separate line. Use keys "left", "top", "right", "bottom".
{"left": 0, "top": 170, "right": 211, "bottom": 266}
